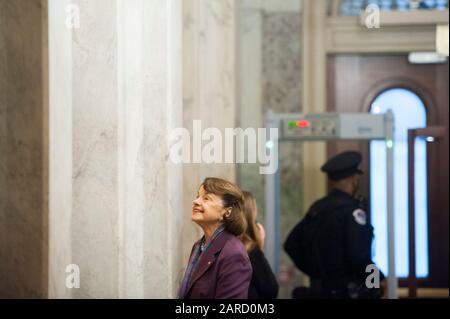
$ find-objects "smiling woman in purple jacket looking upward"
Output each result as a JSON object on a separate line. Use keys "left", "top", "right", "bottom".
{"left": 178, "top": 178, "right": 252, "bottom": 299}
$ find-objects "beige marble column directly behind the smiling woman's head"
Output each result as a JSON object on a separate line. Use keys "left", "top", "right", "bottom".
{"left": 183, "top": 0, "right": 241, "bottom": 264}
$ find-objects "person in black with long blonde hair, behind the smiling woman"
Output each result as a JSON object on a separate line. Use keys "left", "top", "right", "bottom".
{"left": 241, "top": 192, "right": 278, "bottom": 299}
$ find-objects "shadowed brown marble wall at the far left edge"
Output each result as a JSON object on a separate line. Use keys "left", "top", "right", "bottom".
{"left": 0, "top": 0, "right": 47, "bottom": 298}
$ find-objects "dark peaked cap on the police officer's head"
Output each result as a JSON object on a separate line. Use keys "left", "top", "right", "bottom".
{"left": 321, "top": 151, "right": 363, "bottom": 181}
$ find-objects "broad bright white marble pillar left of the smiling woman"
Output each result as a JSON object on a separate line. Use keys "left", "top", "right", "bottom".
{"left": 49, "top": 0, "right": 183, "bottom": 298}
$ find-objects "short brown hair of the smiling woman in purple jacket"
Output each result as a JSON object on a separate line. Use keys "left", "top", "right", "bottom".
{"left": 201, "top": 177, "right": 247, "bottom": 236}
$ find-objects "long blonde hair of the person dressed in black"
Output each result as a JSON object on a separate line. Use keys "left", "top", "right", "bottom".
{"left": 240, "top": 192, "right": 262, "bottom": 252}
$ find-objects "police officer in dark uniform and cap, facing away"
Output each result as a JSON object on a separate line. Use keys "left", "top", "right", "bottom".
{"left": 284, "top": 151, "right": 385, "bottom": 298}
